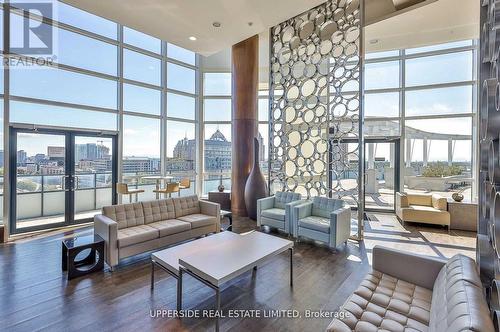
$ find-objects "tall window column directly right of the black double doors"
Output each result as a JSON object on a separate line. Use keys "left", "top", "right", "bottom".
{"left": 121, "top": 27, "right": 164, "bottom": 200}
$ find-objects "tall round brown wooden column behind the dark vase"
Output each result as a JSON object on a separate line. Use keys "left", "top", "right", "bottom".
{"left": 231, "top": 35, "right": 259, "bottom": 217}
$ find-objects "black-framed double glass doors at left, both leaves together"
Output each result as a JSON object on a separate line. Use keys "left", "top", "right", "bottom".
{"left": 9, "top": 128, "right": 117, "bottom": 234}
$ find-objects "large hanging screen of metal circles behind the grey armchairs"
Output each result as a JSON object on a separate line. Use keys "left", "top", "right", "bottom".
{"left": 270, "top": 0, "right": 361, "bottom": 198}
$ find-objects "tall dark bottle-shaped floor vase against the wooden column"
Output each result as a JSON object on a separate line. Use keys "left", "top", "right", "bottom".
{"left": 245, "top": 137, "right": 267, "bottom": 220}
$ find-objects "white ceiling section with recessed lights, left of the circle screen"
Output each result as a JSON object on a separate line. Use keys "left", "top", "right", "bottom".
{"left": 63, "top": 0, "right": 325, "bottom": 55}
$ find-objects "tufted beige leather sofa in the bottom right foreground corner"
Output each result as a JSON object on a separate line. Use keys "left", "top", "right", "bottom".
{"left": 327, "top": 246, "right": 494, "bottom": 332}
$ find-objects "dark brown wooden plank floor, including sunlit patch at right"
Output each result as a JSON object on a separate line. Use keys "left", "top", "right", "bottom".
{"left": 0, "top": 214, "right": 475, "bottom": 332}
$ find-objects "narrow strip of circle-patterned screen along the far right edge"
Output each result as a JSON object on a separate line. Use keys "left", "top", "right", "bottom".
{"left": 476, "top": 0, "right": 500, "bottom": 294}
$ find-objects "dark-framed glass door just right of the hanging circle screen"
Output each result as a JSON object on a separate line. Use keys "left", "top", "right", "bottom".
{"left": 365, "top": 139, "right": 400, "bottom": 211}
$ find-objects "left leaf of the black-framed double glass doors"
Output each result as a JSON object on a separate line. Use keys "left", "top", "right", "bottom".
{"left": 10, "top": 131, "right": 70, "bottom": 233}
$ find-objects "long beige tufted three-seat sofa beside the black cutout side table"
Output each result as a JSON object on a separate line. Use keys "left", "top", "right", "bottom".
{"left": 94, "top": 195, "right": 220, "bottom": 268}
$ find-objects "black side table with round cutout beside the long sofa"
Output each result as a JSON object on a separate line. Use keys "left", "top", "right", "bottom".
{"left": 62, "top": 234, "right": 104, "bottom": 280}
